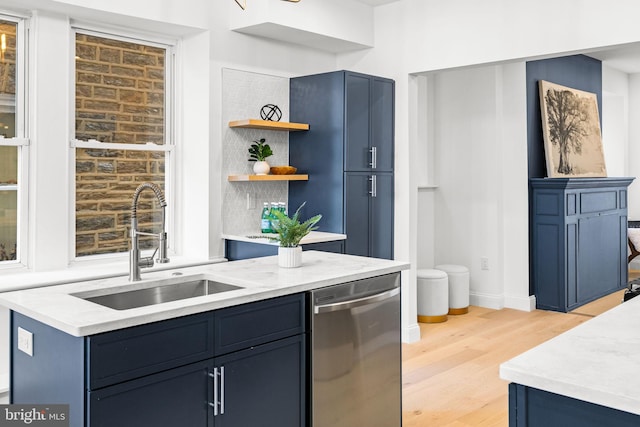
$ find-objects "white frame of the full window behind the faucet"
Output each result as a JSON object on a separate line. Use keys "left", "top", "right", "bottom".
{"left": 69, "top": 22, "right": 178, "bottom": 264}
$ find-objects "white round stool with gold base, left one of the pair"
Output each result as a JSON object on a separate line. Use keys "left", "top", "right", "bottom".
{"left": 417, "top": 269, "right": 449, "bottom": 323}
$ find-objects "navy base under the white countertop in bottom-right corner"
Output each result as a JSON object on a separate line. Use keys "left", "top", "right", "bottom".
{"left": 509, "top": 383, "right": 640, "bottom": 427}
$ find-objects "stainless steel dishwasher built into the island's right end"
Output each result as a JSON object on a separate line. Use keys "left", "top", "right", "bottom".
{"left": 311, "top": 273, "right": 402, "bottom": 427}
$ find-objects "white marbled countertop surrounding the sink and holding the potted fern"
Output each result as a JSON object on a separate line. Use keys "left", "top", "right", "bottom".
{"left": 0, "top": 251, "right": 409, "bottom": 336}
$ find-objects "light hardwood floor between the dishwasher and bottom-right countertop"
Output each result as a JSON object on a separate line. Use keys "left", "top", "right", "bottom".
{"left": 402, "top": 273, "right": 639, "bottom": 427}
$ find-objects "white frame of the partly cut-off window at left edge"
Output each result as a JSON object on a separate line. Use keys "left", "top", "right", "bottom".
{"left": 0, "top": 11, "right": 30, "bottom": 270}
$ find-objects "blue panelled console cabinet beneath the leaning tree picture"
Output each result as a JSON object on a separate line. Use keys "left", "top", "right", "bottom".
{"left": 530, "top": 178, "right": 633, "bottom": 312}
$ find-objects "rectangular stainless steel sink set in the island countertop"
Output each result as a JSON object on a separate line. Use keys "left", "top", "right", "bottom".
{"left": 80, "top": 279, "right": 242, "bottom": 310}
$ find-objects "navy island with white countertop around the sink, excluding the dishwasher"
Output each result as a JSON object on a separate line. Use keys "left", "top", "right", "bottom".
{"left": 0, "top": 251, "right": 409, "bottom": 427}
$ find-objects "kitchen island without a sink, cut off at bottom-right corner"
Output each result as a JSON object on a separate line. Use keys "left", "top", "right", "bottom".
{"left": 500, "top": 298, "right": 640, "bottom": 427}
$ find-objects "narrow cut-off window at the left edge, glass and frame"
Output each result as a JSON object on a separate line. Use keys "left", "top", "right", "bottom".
{"left": 0, "top": 15, "right": 28, "bottom": 265}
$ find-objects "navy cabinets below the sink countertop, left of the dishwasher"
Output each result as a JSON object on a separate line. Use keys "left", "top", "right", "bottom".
{"left": 11, "top": 294, "right": 308, "bottom": 427}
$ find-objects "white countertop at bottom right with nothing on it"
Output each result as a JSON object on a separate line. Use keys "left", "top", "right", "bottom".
{"left": 500, "top": 297, "right": 640, "bottom": 415}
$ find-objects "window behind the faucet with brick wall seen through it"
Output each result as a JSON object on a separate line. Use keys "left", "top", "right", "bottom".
{"left": 74, "top": 29, "right": 173, "bottom": 257}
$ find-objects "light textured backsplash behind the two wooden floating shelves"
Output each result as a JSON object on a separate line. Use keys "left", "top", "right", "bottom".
{"left": 222, "top": 69, "right": 289, "bottom": 234}
